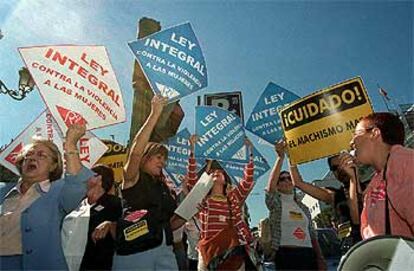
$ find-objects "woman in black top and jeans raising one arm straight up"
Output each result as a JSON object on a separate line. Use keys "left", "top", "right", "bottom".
{"left": 113, "top": 95, "right": 177, "bottom": 270}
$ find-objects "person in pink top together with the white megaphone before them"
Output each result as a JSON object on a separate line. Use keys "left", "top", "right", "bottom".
{"left": 338, "top": 112, "right": 414, "bottom": 270}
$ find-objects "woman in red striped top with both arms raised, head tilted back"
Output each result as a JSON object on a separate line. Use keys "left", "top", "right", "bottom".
{"left": 187, "top": 136, "right": 254, "bottom": 270}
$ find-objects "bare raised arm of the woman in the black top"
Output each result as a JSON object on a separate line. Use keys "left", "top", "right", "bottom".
{"left": 122, "top": 95, "right": 167, "bottom": 189}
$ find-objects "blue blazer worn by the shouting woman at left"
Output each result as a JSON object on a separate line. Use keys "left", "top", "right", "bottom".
{"left": 0, "top": 167, "right": 93, "bottom": 270}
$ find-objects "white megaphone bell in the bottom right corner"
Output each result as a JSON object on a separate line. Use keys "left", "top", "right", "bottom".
{"left": 338, "top": 235, "right": 414, "bottom": 271}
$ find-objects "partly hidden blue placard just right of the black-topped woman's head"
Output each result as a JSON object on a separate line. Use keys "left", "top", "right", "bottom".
{"left": 164, "top": 129, "right": 202, "bottom": 186}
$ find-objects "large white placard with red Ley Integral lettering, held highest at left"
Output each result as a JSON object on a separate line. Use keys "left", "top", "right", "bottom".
{"left": 19, "top": 45, "right": 126, "bottom": 133}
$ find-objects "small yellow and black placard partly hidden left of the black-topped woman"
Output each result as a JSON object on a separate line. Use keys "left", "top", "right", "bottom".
{"left": 97, "top": 139, "right": 128, "bottom": 183}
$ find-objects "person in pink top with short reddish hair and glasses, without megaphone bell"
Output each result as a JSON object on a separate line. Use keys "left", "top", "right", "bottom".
{"left": 342, "top": 112, "right": 414, "bottom": 239}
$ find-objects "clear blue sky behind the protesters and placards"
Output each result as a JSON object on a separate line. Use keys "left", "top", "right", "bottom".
{"left": 0, "top": 0, "right": 414, "bottom": 225}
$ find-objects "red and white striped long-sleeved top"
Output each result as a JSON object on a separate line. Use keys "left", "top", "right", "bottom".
{"left": 187, "top": 155, "right": 254, "bottom": 244}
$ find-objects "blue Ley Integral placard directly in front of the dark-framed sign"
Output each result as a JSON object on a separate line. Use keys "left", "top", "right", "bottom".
{"left": 195, "top": 106, "right": 248, "bottom": 163}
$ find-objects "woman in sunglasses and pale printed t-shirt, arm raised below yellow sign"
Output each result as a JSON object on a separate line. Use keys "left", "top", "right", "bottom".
{"left": 266, "top": 141, "right": 326, "bottom": 270}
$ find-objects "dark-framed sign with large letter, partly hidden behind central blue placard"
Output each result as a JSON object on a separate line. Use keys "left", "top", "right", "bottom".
{"left": 204, "top": 91, "right": 244, "bottom": 123}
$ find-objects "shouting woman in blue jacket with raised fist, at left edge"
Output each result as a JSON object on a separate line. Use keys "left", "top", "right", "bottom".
{"left": 0, "top": 125, "right": 93, "bottom": 270}
